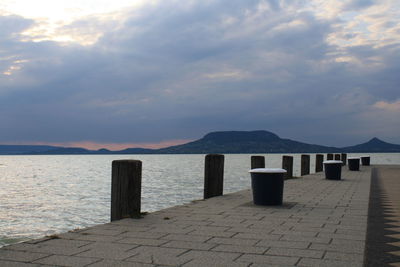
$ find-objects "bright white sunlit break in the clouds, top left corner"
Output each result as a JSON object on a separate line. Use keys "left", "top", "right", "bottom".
{"left": 0, "top": 0, "right": 148, "bottom": 45}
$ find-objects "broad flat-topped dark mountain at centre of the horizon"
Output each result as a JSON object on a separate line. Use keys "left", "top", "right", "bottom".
{"left": 157, "top": 131, "right": 340, "bottom": 154}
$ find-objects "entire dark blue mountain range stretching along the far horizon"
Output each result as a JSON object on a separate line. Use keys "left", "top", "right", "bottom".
{"left": 0, "top": 131, "right": 400, "bottom": 155}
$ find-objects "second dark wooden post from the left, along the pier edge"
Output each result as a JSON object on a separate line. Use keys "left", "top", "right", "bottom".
{"left": 204, "top": 154, "right": 225, "bottom": 199}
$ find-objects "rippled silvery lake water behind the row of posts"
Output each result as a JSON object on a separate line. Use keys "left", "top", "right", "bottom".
{"left": 0, "top": 153, "right": 400, "bottom": 246}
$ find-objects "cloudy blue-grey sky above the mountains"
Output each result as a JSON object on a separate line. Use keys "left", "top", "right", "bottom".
{"left": 0, "top": 0, "right": 400, "bottom": 150}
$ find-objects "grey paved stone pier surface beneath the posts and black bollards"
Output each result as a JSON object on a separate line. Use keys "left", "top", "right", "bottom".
{"left": 0, "top": 166, "right": 380, "bottom": 267}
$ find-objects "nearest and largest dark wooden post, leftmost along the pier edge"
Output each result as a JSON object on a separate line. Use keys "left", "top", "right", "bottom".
{"left": 111, "top": 160, "right": 142, "bottom": 221}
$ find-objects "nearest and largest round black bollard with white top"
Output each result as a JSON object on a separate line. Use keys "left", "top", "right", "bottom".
{"left": 249, "top": 168, "right": 286, "bottom": 205}
